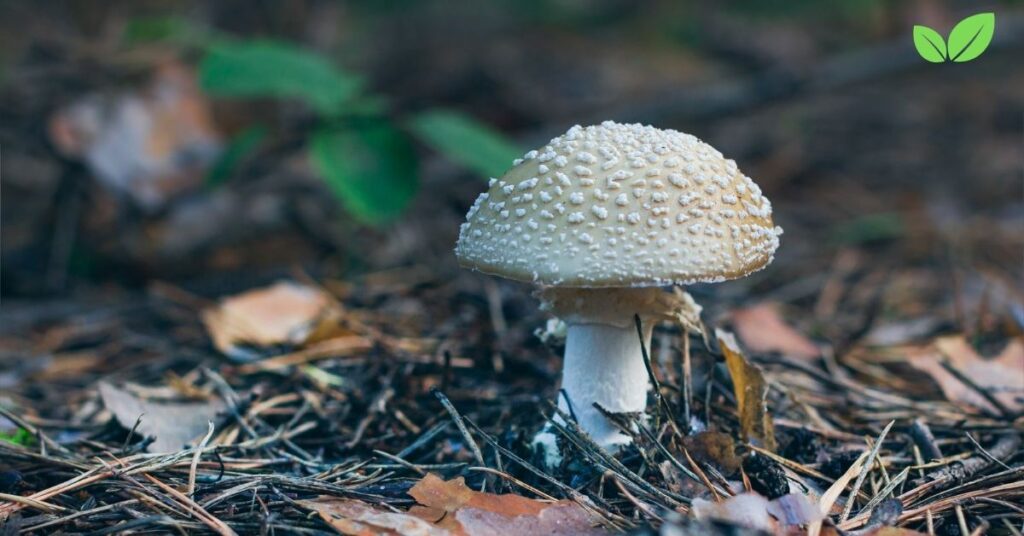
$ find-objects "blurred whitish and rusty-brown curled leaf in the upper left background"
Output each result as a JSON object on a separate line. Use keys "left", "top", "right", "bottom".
{"left": 49, "top": 63, "right": 221, "bottom": 209}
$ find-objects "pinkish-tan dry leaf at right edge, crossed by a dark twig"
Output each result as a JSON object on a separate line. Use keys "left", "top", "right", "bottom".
{"left": 908, "top": 335, "right": 1024, "bottom": 412}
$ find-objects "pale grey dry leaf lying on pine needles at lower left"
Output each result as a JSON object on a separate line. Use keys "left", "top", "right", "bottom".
{"left": 99, "top": 382, "right": 224, "bottom": 453}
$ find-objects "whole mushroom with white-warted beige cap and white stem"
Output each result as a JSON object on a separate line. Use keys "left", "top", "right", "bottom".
{"left": 456, "top": 121, "right": 782, "bottom": 457}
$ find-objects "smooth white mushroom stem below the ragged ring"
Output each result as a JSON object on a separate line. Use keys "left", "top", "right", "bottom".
{"left": 558, "top": 323, "right": 651, "bottom": 451}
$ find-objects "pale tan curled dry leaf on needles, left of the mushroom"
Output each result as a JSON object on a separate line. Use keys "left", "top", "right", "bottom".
{"left": 202, "top": 281, "right": 351, "bottom": 361}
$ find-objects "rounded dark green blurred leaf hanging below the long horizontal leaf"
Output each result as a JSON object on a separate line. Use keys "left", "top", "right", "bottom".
{"left": 309, "top": 120, "right": 417, "bottom": 224}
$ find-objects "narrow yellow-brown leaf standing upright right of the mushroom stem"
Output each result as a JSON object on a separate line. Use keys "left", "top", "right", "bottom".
{"left": 715, "top": 329, "right": 775, "bottom": 452}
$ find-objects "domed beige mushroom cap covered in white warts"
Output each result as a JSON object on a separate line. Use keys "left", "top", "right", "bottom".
{"left": 456, "top": 121, "right": 782, "bottom": 287}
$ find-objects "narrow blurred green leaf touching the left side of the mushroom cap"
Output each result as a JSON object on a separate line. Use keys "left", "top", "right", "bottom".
{"left": 409, "top": 110, "right": 523, "bottom": 177}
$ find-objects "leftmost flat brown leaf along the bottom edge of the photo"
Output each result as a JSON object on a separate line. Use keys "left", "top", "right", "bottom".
{"left": 298, "top": 496, "right": 452, "bottom": 536}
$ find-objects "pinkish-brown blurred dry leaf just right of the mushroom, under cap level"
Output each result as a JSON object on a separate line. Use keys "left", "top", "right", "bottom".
{"left": 732, "top": 303, "right": 821, "bottom": 360}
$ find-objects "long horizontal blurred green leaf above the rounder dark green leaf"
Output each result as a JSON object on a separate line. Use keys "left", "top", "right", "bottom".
{"left": 199, "top": 41, "right": 361, "bottom": 115}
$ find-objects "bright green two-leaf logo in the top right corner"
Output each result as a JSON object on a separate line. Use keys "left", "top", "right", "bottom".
{"left": 913, "top": 13, "right": 995, "bottom": 64}
